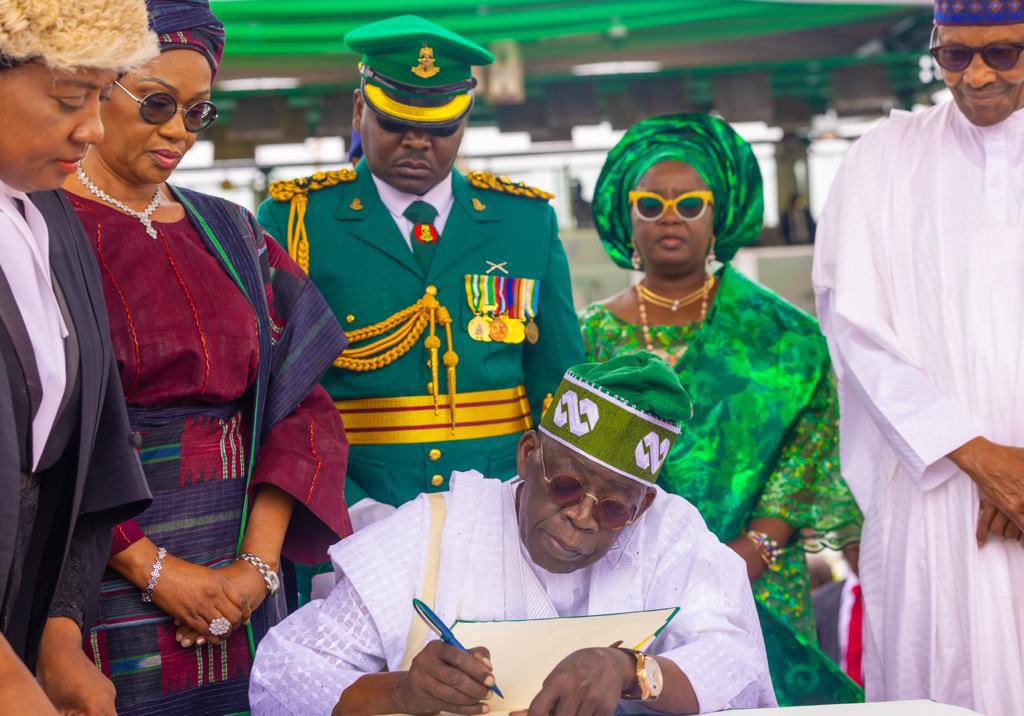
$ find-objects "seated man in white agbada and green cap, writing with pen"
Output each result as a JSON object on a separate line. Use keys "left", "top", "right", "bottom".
{"left": 250, "top": 353, "right": 775, "bottom": 716}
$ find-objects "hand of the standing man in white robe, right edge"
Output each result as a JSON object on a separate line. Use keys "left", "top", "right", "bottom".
{"left": 949, "top": 437, "right": 1024, "bottom": 539}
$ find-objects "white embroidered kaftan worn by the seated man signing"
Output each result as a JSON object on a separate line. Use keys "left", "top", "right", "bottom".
{"left": 249, "top": 472, "right": 775, "bottom": 716}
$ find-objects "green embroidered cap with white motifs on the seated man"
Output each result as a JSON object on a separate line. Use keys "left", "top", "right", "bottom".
{"left": 540, "top": 351, "right": 693, "bottom": 482}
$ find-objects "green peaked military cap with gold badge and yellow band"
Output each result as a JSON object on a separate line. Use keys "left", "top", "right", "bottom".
{"left": 345, "top": 15, "right": 495, "bottom": 127}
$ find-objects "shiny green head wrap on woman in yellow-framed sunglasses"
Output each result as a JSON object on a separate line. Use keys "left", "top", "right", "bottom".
{"left": 594, "top": 114, "right": 764, "bottom": 268}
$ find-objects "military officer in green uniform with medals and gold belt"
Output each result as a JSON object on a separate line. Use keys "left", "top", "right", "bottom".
{"left": 259, "top": 15, "right": 583, "bottom": 524}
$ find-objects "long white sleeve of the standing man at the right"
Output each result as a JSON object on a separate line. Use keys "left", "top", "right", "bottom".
{"left": 813, "top": 120, "right": 980, "bottom": 493}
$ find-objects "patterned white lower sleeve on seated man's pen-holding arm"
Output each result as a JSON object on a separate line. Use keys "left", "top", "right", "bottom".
{"left": 249, "top": 577, "right": 386, "bottom": 716}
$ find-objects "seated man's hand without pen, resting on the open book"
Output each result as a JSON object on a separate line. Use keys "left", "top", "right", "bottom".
{"left": 513, "top": 648, "right": 637, "bottom": 716}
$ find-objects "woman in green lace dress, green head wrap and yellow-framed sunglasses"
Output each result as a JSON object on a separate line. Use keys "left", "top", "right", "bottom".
{"left": 580, "top": 115, "right": 863, "bottom": 706}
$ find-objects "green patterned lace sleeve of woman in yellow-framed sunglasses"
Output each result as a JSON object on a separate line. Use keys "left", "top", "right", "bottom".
{"left": 751, "top": 373, "right": 863, "bottom": 551}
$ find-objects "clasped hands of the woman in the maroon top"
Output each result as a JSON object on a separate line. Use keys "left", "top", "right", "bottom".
{"left": 153, "top": 554, "right": 249, "bottom": 646}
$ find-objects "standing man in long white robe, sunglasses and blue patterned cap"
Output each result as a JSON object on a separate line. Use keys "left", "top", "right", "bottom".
{"left": 814, "top": 0, "right": 1024, "bottom": 716}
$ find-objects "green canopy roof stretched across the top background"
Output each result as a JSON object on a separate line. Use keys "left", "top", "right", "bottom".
{"left": 211, "top": 0, "right": 911, "bottom": 65}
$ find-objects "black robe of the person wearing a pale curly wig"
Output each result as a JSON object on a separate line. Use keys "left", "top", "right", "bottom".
{"left": 0, "top": 187, "right": 152, "bottom": 668}
